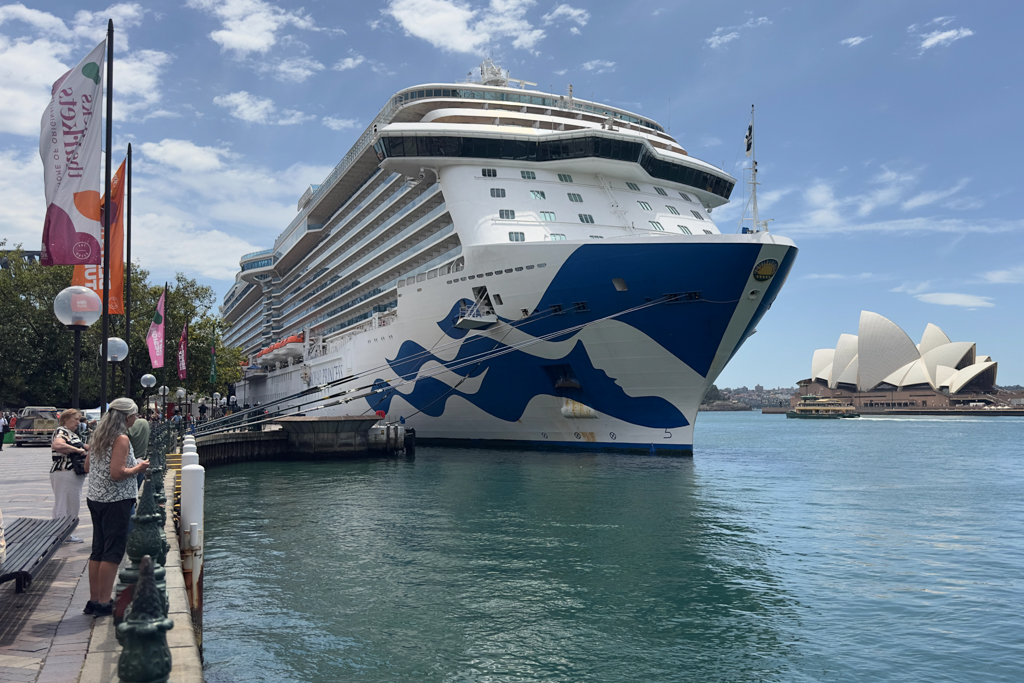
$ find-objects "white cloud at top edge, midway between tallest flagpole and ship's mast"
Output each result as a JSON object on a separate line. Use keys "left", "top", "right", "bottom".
{"left": 186, "top": 0, "right": 316, "bottom": 57}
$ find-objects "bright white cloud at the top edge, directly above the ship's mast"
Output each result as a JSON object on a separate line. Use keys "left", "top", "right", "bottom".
{"left": 384, "top": 0, "right": 545, "bottom": 54}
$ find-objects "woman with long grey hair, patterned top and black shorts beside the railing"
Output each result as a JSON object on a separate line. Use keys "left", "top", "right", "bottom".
{"left": 83, "top": 398, "right": 150, "bottom": 616}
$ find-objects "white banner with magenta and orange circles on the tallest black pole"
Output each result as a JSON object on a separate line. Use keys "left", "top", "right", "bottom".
{"left": 39, "top": 40, "right": 106, "bottom": 265}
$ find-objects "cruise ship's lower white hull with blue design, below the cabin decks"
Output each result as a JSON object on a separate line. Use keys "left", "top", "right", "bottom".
{"left": 236, "top": 232, "right": 797, "bottom": 453}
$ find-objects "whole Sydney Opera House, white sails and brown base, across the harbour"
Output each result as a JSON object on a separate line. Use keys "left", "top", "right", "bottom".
{"left": 795, "top": 310, "right": 996, "bottom": 412}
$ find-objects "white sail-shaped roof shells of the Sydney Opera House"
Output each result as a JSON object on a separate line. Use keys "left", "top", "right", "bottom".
{"left": 811, "top": 310, "right": 997, "bottom": 394}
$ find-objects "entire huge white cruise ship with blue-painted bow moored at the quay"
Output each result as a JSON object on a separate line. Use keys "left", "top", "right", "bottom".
{"left": 220, "top": 61, "right": 797, "bottom": 454}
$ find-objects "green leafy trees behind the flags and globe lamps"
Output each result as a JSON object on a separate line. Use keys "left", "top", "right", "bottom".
{"left": 0, "top": 241, "right": 244, "bottom": 409}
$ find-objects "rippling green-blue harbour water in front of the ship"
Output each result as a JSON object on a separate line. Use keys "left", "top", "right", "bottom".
{"left": 204, "top": 413, "right": 1024, "bottom": 683}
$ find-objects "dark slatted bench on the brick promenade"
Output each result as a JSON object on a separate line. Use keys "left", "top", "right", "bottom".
{"left": 0, "top": 517, "right": 78, "bottom": 593}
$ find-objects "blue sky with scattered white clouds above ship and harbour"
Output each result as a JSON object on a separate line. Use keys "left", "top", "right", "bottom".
{"left": 0, "top": 0, "right": 1024, "bottom": 387}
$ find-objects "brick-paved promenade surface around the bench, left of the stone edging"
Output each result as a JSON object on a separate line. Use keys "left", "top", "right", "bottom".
{"left": 0, "top": 444, "right": 94, "bottom": 683}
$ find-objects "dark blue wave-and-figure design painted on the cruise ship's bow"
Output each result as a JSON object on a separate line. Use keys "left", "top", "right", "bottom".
{"left": 368, "top": 244, "right": 796, "bottom": 429}
